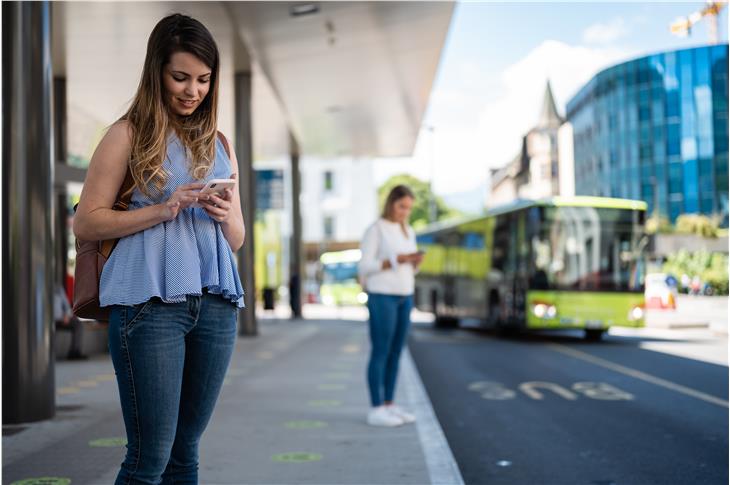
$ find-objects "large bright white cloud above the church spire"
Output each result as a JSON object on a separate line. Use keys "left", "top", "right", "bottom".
{"left": 375, "top": 40, "right": 636, "bottom": 198}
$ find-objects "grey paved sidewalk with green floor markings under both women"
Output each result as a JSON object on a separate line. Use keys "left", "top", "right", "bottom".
{"left": 3, "top": 320, "right": 463, "bottom": 485}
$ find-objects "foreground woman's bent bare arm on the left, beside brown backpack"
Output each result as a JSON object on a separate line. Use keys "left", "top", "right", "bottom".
{"left": 73, "top": 121, "right": 203, "bottom": 241}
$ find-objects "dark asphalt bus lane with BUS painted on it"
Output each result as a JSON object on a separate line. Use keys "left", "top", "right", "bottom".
{"left": 409, "top": 324, "right": 728, "bottom": 485}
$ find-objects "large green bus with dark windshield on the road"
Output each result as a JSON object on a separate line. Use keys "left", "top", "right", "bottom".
{"left": 415, "top": 197, "right": 648, "bottom": 340}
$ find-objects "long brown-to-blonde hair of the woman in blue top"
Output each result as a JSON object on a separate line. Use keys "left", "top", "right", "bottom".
{"left": 121, "top": 14, "right": 219, "bottom": 196}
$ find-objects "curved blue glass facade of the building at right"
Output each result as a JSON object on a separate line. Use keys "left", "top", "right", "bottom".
{"left": 567, "top": 44, "right": 728, "bottom": 224}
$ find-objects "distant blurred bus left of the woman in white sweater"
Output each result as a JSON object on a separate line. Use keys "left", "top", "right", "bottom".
{"left": 319, "top": 249, "right": 368, "bottom": 306}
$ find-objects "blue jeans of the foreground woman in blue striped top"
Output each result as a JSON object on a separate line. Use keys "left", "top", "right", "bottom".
{"left": 109, "top": 293, "right": 237, "bottom": 485}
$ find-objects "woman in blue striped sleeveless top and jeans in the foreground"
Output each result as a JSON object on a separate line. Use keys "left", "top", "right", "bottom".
{"left": 74, "top": 14, "right": 245, "bottom": 484}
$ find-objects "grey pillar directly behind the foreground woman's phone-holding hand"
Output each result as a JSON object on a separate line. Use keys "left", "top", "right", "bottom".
{"left": 235, "top": 72, "right": 258, "bottom": 336}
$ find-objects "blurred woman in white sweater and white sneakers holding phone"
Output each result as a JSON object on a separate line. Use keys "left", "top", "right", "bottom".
{"left": 359, "top": 185, "right": 423, "bottom": 426}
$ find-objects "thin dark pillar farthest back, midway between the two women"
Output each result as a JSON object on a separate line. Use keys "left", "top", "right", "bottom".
{"left": 289, "top": 134, "right": 303, "bottom": 318}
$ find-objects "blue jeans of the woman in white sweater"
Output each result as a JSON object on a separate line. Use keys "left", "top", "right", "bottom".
{"left": 368, "top": 293, "right": 413, "bottom": 406}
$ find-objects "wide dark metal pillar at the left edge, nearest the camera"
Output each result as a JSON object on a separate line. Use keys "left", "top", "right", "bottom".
{"left": 2, "top": 2, "right": 55, "bottom": 424}
